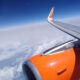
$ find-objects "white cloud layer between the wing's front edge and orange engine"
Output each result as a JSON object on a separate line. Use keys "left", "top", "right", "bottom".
{"left": 0, "top": 20, "right": 79, "bottom": 80}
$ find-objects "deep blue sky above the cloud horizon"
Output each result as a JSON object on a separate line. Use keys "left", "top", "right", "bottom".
{"left": 0, "top": 0, "right": 80, "bottom": 29}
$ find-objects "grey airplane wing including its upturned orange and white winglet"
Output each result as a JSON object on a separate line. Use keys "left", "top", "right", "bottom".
{"left": 48, "top": 7, "right": 80, "bottom": 39}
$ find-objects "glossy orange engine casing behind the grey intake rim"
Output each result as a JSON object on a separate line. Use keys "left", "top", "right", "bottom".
{"left": 29, "top": 48, "right": 80, "bottom": 80}
